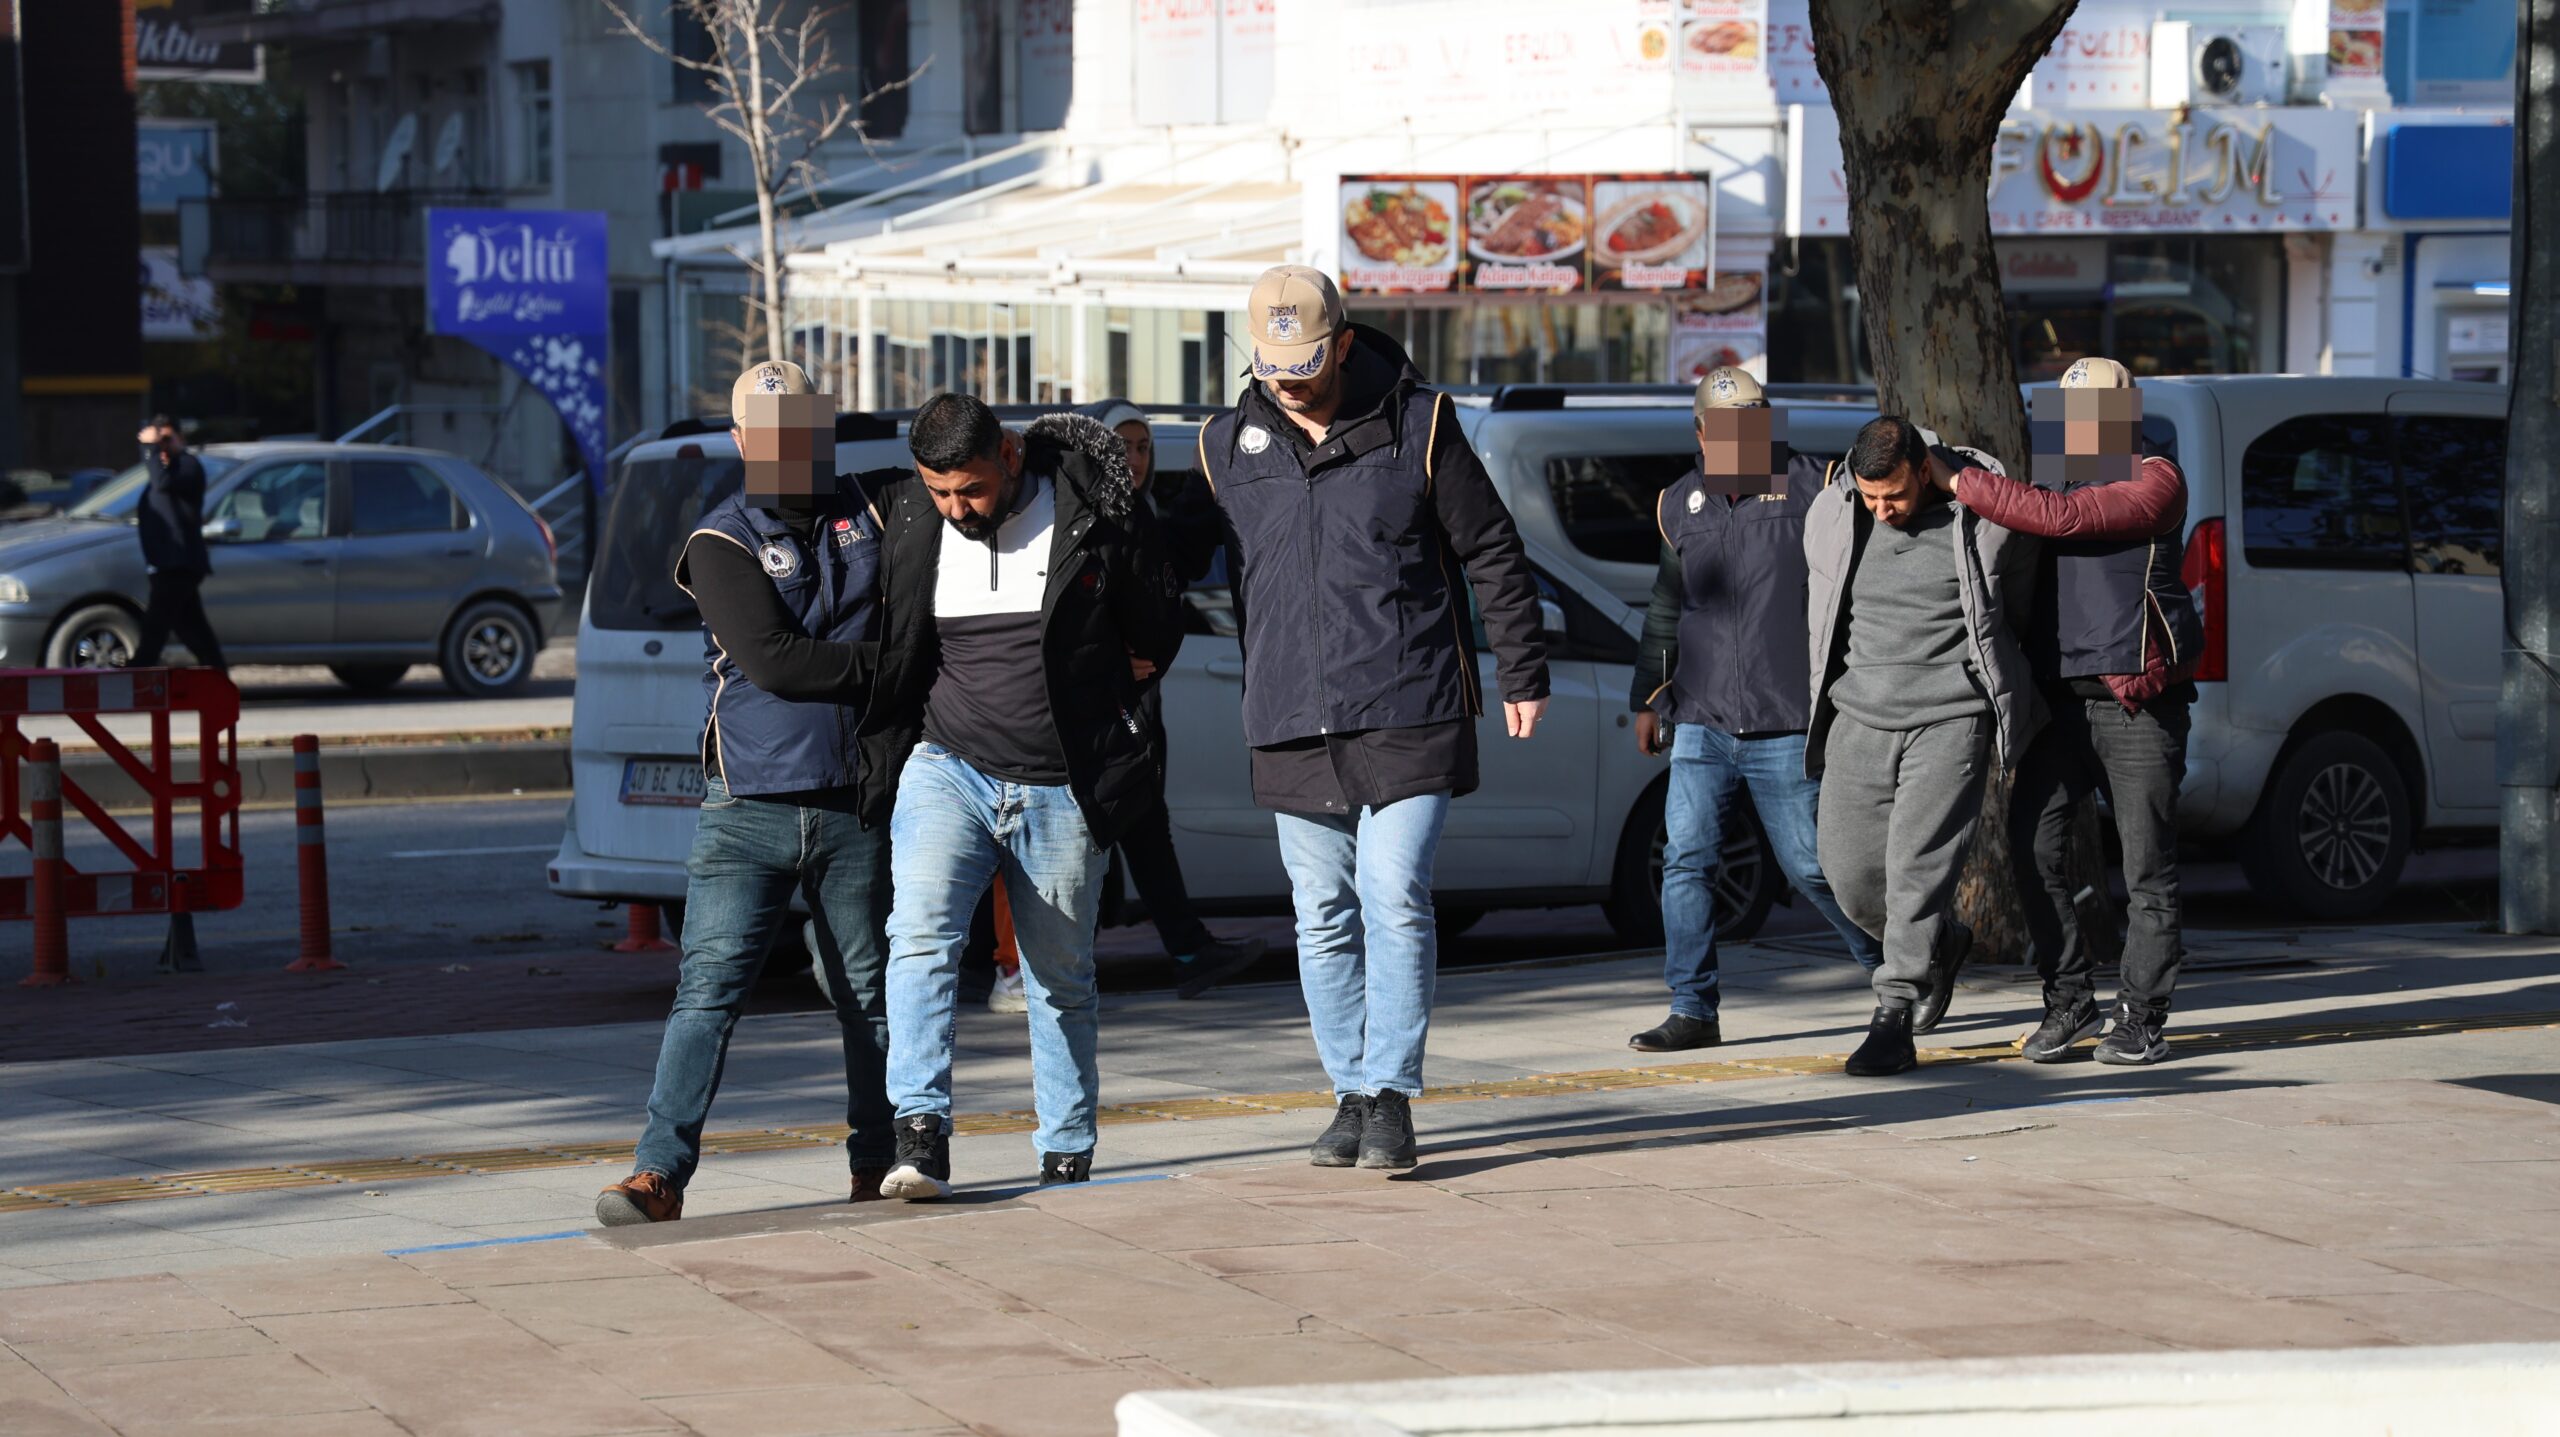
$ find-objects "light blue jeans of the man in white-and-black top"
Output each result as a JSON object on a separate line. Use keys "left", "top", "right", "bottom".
{"left": 888, "top": 743, "right": 1111, "bottom": 1153}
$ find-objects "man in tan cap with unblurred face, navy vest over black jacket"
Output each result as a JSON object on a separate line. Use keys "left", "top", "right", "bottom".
{"left": 1201, "top": 264, "right": 1546, "bottom": 1168}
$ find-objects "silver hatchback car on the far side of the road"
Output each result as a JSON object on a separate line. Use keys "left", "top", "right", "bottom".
{"left": 0, "top": 443, "right": 561, "bottom": 697}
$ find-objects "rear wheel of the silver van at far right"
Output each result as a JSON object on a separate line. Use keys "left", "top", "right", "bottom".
{"left": 2240, "top": 730, "right": 2417, "bottom": 920}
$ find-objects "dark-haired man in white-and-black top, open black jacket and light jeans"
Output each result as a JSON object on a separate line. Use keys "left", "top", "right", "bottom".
{"left": 865, "top": 394, "right": 1180, "bottom": 1201}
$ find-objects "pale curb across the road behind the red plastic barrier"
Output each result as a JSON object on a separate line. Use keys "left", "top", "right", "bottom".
{"left": 61, "top": 738, "right": 568, "bottom": 809}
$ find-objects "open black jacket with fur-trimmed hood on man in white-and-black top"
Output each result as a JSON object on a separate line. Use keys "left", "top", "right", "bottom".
{"left": 863, "top": 415, "right": 1183, "bottom": 848}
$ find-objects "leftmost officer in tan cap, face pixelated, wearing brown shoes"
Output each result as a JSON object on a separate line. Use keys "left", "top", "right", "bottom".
{"left": 596, "top": 361, "right": 896, "bottom": 1227}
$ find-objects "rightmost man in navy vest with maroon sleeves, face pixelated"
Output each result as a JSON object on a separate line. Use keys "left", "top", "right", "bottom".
{"left": 1930, "top": 359, "right": 2204, "bottom": 1063}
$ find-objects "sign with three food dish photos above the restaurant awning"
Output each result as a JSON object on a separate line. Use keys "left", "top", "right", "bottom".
{"left": 1336, "top": 174, "right": 1715, "bottom": 295}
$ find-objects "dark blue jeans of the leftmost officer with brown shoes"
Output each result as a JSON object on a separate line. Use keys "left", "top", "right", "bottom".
{"left": 637, "top": 779, "right": 896, "bottom": 1189}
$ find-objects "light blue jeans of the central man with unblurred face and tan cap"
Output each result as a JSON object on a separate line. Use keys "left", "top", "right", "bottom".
{"left": 1277, "top": 794, "right": 1449, "bottom": 1096}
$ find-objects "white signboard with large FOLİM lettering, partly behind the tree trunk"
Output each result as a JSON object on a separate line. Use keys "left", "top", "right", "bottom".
{"left": 1787, "top": 105, "right": 2363, "bottom": 236}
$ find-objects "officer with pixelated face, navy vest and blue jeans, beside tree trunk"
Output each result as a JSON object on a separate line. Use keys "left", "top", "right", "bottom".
{"left": 1628, "top": 369, "right": 1894, "bottom": 1053}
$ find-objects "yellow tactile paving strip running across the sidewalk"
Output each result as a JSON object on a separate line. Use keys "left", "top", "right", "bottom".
{"left": 0, "top": 1012, "right": 2560, "bottom": 1214}
